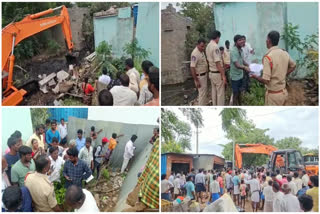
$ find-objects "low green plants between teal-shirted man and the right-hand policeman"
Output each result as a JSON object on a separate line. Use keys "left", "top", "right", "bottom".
{"left": 242, "top": 78, "right": 265, "bottom": 106}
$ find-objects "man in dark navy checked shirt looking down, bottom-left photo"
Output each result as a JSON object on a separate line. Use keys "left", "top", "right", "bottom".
{"left": 63, "top": 148, "right": 92, "bottom": 188}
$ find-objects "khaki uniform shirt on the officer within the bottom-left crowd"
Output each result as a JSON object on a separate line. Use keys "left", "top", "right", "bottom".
{"left": 25, "top": 172, "right": 58, "bottom": 212}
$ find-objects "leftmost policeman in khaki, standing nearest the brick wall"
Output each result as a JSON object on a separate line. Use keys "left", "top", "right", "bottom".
{"left": 190, "top": 39, "right": 208, "bottom": 106}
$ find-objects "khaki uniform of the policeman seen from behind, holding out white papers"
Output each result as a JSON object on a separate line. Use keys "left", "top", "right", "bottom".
{"left": 262, "top": 46, "right": 296, "bottom": 106}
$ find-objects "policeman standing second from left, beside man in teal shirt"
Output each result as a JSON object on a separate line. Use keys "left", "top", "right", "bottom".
{"left": 206, "top": 30, "right": 227, "bottom": 106}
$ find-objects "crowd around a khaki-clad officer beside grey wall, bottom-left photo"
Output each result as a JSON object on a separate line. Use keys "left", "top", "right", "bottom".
{"left": 2, "top": 118, "right": 159, "bottom": 212}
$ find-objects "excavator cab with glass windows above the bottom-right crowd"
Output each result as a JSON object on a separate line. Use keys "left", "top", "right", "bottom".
{"left": 268, "top": 149, "right": 304, "bottom": 174}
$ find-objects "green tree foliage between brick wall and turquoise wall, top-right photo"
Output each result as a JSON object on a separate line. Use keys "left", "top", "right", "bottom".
{"left": 177, "top": 2, "right": 216, "bottom": 59}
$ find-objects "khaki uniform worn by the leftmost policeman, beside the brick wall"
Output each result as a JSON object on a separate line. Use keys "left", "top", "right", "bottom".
{"left": 190, "top": 47, "right": 208, "bottom": 106}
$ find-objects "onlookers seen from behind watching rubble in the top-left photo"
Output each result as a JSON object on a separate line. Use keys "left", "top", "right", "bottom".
{"left": 81, "top": 58, "right": 159, "bottom": 106}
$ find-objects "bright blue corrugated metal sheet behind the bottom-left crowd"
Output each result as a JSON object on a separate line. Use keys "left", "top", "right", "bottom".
{"left": 48, "top": 108, "right": 88, "bottom": 122}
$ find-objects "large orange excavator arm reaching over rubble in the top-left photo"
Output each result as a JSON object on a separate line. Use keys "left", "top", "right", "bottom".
{"left": 2, "top": 6, "right": 73, "bottom": 105}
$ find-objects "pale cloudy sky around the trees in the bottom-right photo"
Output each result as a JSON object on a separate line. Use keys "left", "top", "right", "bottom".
{"left": 168, "top": 107, "right": 319, "bottom": 156}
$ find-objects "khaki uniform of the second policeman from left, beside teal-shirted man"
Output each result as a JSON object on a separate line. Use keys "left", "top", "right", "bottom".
{"left": 206, "top": 41, "right": 224, "bottom": 106}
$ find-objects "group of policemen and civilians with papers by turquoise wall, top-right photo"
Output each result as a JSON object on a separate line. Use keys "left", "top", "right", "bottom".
{"left": 190, "top": 30, "right": 296, "bottom": 106}
